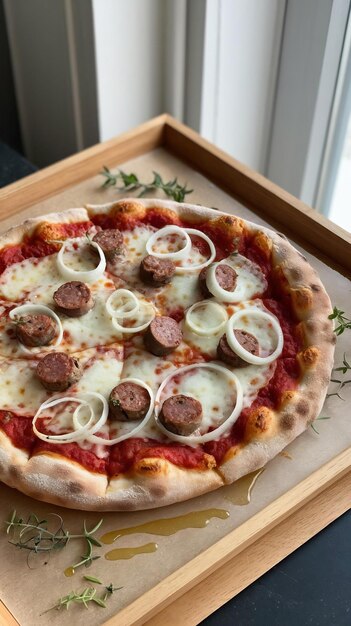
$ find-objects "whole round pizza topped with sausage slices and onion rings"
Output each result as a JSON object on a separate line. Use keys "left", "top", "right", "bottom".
{"left": 0, "top": 198, "right": 335, "bottom": 511}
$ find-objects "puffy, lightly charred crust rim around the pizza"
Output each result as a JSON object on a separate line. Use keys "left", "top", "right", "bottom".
{"left": 0, "top": 198, "right": 335, "bottom": 511}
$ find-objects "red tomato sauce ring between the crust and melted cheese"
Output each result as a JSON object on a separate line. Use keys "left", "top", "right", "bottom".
{"left": 0, "top": 208, "right": 300, "bottom": 476}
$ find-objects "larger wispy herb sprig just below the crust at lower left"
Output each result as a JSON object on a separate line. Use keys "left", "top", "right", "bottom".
{"left": 5, "top": 511, "right": 103, "bottom": 569}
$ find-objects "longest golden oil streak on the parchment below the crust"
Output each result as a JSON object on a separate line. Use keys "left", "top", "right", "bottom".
{"left": 101, "top": 509, "right": 229, "bottom": 543}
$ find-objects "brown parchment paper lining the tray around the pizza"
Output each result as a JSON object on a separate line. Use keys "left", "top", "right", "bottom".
{"left": 0, "top": 149, "right": 351, "bottom": 626}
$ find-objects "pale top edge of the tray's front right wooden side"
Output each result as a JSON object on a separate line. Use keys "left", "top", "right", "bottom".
{"left": 105, "top": 448, "right": 351, "bottom": 626}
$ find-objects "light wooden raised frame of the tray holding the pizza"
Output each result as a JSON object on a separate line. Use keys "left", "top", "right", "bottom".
{"left": 0, "top": 114, "right": 351, "bottom": 626}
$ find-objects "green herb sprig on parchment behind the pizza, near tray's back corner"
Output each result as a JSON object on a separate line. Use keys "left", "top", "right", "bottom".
{"left": 100, "top": 165, "right": 193, "bottom": 202}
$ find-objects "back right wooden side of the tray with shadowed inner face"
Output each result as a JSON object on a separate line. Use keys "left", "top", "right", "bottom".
{"left": 165, "top": 118, "right": 351, "bottom": 272}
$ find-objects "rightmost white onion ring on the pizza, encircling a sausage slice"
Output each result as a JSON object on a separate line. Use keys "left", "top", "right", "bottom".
{"left": 226, "top": 308, "right": 284, "bottom": 365}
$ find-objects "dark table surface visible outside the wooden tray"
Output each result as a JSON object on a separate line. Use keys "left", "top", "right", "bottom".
{"left": 0, "top": 142, "right": 351, "bottom": 626}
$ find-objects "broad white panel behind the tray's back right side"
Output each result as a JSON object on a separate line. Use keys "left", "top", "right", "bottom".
{"left": 187, "top": 0, "right": 285, "bottom": 171}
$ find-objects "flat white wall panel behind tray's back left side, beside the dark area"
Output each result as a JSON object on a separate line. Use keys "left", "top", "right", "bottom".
{"left": 93, "top": 0, "right": 164, "bottom": 141}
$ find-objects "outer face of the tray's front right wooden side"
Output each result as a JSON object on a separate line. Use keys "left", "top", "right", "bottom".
{"left": 144, "top": 472, "right": 351, "bottom": 626}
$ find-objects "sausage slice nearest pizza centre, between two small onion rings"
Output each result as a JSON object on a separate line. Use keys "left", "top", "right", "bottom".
{"left": 144, "top": 315, "right": 183, "bottom": 356}
